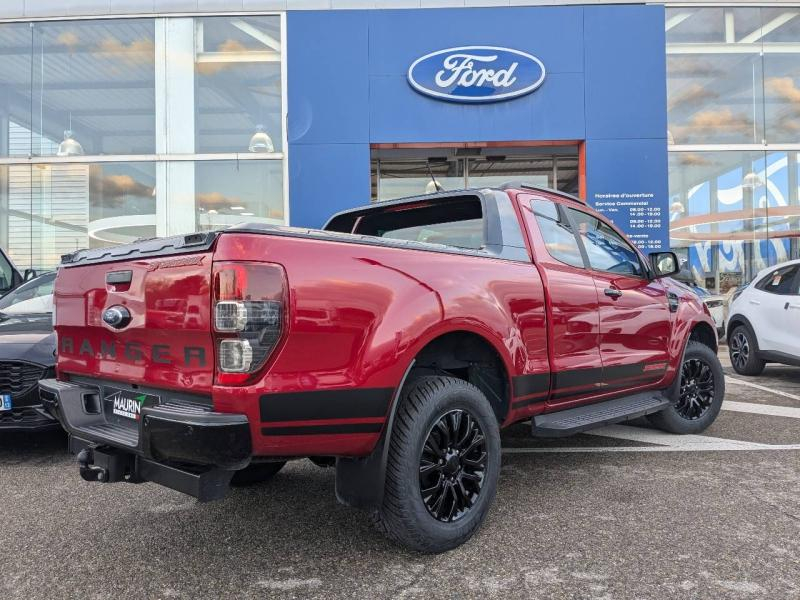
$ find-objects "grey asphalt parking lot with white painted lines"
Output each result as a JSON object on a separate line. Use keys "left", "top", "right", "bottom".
{"left": 0, "top": 354, "right": 800, "bottom": 600}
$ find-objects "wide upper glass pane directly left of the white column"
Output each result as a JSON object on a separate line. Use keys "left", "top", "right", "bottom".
{"left": 29, "top": 19, "right": 155, "bottom": 156}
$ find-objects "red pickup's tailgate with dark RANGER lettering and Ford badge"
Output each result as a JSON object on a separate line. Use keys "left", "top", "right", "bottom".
{"left": 54, "top": 234, "right": 215, "bottom": 394}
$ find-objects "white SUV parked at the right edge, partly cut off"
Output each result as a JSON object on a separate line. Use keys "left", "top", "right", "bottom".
{"left": 727, "top": 260, "right": 800, "bottom": 375}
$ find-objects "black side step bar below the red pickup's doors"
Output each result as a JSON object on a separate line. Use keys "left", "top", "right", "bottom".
{"left": 531, "top": 391, "right": 672, "bottom": 438}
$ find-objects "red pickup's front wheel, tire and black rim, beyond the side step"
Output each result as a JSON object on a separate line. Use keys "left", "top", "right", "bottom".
{"left": 647, "top": 340, "right": 725, "bottom": 434}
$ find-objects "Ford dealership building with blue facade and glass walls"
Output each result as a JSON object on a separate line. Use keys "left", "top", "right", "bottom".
{"left": 0, "top": 0, "right": 800, "bottom": 291}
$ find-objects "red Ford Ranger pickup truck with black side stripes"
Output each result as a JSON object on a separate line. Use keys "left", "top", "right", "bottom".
{"left": 41, "top": 185, "right": 724, "bottom": 552}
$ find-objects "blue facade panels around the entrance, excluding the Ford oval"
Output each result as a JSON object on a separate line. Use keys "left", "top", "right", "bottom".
{"left": 287, "top": 6, "right": 668, "bottom": 249}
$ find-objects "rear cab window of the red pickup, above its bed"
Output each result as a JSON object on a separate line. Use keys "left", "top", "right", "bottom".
{"left": 353, "top": 198, "right": 485, "bottom": 250}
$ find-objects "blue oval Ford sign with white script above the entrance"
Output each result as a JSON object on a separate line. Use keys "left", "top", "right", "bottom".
{"left": 408, "top": 46, "right": 545, "bottom": 103}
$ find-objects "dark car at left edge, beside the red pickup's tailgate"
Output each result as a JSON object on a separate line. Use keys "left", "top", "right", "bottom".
{"left": 0, "top": 273, "right": 59, "bottom": 431}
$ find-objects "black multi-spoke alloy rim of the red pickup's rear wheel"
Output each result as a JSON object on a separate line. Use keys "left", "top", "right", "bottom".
{"left": 419, "top": 409, "right": 488, "bottom": 523}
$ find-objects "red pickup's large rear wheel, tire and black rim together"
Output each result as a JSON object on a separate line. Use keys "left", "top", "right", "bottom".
{"left": 373, "top": 377, "right": 500, "bottom": 553}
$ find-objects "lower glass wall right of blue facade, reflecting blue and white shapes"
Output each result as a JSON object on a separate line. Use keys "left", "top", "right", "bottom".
{"left": 670, "top": 152, "right": 800, "bottom": 293}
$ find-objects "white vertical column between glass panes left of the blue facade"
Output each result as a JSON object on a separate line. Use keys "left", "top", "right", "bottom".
{"left": 155, "top": 18, "right": 196, "bottom": 236}
